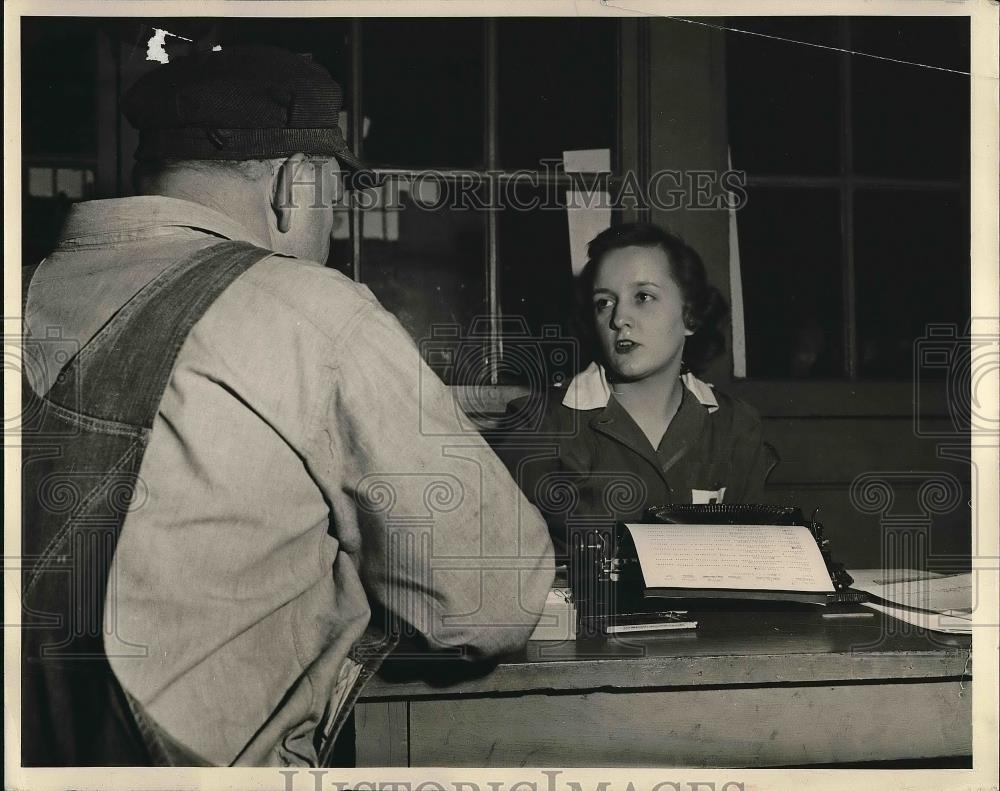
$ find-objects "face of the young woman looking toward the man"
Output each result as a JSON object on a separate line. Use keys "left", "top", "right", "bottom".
{"left": 593, "top": 247, "right": 691, "bottom": 381}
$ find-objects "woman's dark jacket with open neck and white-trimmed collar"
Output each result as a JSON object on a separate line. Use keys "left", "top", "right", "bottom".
{"left": 496, "top": 371, "right": 777, "bottom": 556}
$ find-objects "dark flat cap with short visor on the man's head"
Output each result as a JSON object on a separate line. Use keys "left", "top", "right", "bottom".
{"left": 123, "top": 46, "right": 364, "bottom": 170}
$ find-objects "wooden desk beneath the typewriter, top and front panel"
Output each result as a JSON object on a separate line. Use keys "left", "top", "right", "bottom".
{"left": 356, "top": 613, "right": 972, "bottom": 767}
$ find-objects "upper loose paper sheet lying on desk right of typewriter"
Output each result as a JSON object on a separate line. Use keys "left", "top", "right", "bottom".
{"left": 851, "top": 569, "right": 972, "bottom": 618}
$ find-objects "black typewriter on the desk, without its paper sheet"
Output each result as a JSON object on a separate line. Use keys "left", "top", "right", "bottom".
{"left": 569, "top": 503, "right": 865, "bottom": 637}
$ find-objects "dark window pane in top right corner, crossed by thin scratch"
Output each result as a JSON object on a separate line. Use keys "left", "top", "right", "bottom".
{"left": 851, "top": 18, "right": 969, "bottom": 180}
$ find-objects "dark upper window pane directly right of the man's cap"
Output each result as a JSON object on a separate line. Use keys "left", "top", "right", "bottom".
{"left": 362, "top": 19, "right": 486, "bottom": 168}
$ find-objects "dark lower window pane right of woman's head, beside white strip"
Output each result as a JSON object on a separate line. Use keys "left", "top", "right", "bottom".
{"left": 738, "top": 188, "right": 844, "bottom": 379}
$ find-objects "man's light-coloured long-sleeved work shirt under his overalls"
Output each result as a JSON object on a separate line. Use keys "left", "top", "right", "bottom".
{"left": 26, "top": 197, "right": 553, "bottom": 765}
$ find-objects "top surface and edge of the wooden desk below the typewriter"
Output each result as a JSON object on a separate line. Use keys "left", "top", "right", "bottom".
{"left": 362, "top": 612, "right": 972, "bottom": 700}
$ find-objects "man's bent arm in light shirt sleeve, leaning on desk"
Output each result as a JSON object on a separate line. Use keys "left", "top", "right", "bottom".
{"left": 306, "top": 306, "right": 554, "bottom": 656}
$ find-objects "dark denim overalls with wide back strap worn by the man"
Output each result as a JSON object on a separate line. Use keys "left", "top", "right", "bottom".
{"left": 21, "top": 241, "right": 274, "bottom": 766}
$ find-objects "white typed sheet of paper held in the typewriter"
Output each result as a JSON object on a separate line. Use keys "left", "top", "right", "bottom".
{"left": 627, "top": 524, "right": 833, "bottom": 593}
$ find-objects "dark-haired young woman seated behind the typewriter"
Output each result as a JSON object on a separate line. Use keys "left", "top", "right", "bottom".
{"left": 497, "top": 223, "right": 776, "bottom": 557}
